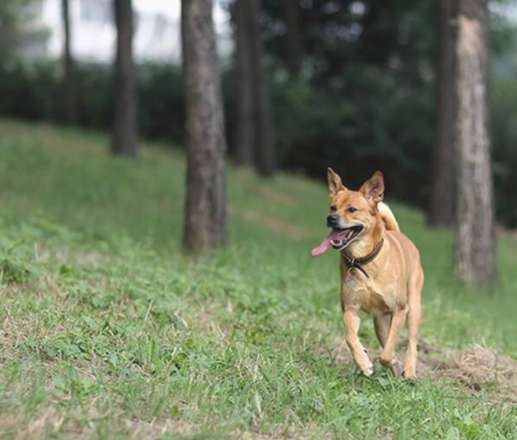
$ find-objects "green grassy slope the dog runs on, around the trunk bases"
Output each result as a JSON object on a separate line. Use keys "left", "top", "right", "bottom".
{"left": 0, "top": 120, "right": 517, "bottom": 439}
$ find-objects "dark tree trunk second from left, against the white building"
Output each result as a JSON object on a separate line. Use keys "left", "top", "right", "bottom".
{"left": 111, "top": 0, "right": 138, "bottom": 158}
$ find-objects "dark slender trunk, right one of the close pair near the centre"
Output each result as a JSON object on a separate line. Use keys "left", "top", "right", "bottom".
{"left": 248, "top": 0, "right": 276, "bottom": 177}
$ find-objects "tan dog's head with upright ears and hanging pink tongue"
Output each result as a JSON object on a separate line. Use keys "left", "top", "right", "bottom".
{"left": 312, "top": 168, "right": 384, "bottom": 256}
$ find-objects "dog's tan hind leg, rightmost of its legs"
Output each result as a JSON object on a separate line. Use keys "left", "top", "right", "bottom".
{"left": 404, "top": 270, "right": 424, "bottom": 378}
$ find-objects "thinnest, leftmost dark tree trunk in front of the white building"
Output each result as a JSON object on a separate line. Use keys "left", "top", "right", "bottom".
{"left": 61, "top": 0, "right": 78, "bottom": 124}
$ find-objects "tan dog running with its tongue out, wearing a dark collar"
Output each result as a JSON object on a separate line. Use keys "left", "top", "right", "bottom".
{"left": 312, "top": 168, "right": 424, "bottom": 378}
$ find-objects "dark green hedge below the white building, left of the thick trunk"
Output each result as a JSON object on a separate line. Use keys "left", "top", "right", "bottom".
{"left": 0, "top": 60, "right": 184, "bottom": 140}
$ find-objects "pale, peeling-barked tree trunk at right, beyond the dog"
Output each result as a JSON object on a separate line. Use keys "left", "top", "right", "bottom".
{"left": 456, "top": 0, "right": 496, "bottom": 281}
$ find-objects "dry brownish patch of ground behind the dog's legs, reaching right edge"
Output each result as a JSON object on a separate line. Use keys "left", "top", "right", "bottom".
{"left": 326, "top": 339, "right": 517, "bottom": 405}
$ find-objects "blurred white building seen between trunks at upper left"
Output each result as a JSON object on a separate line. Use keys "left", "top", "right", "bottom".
{"left": 22, "top": 0, "right": 232, "bottom": 64}
